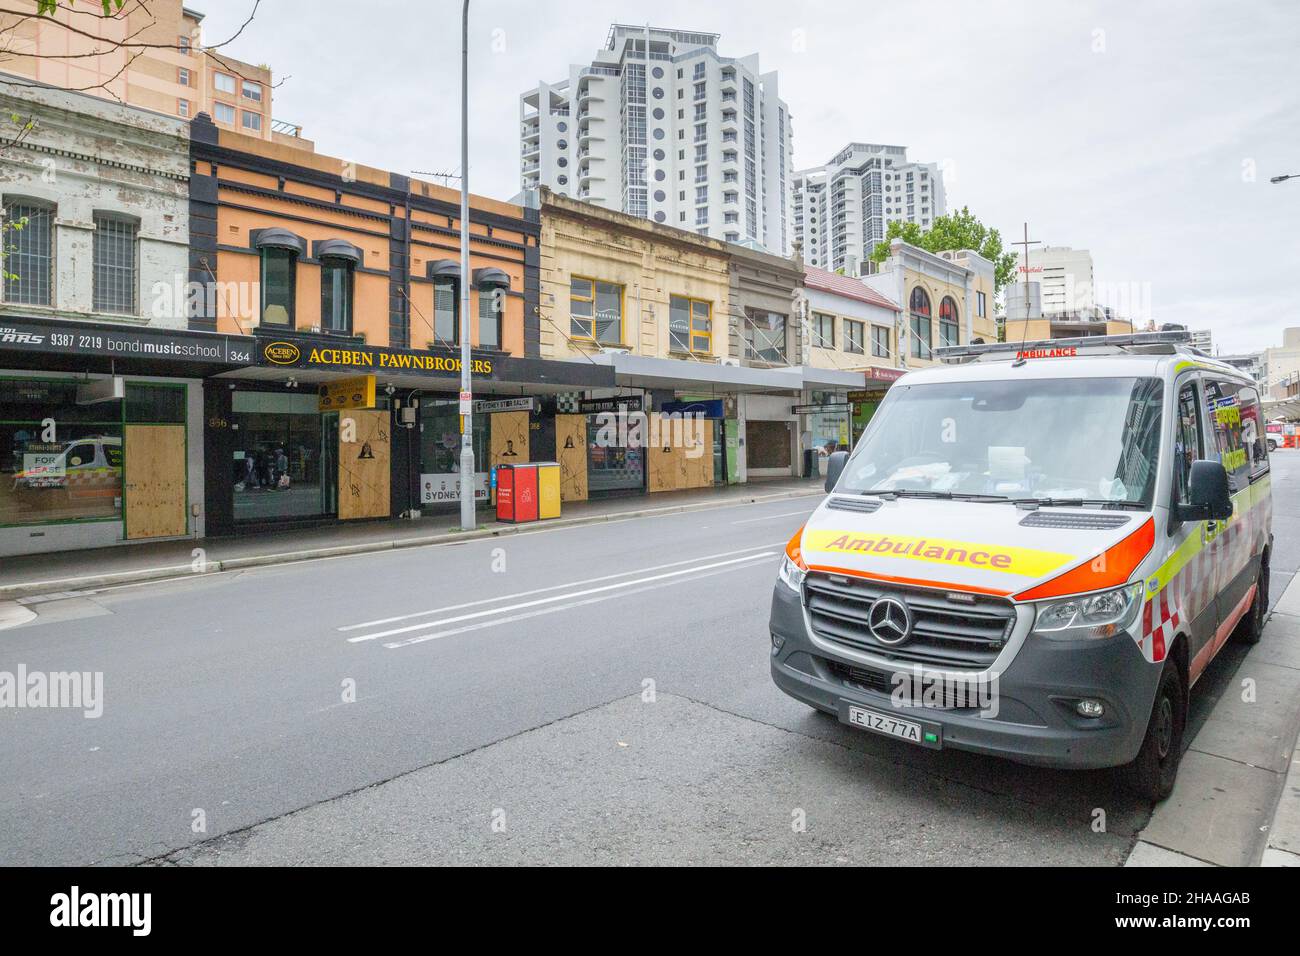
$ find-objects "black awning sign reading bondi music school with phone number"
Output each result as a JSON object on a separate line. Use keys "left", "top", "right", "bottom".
{"left": 0, "top": 317, "right": 254, "bottom": 365}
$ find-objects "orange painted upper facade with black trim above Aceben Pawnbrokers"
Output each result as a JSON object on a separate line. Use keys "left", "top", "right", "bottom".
{"left": 190, "top": 117, "right": 540, "bottom": 358}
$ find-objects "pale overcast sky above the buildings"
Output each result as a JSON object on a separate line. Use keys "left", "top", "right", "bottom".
{"left": 192, "top": 0, "right": 1300, "bottom": 354}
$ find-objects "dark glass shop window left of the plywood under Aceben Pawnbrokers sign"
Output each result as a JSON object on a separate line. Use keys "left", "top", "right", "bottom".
{"left": 231, "top": 392, "right": 338, "bottom": 522}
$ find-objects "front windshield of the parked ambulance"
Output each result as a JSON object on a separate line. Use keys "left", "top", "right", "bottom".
{"left": 836, "top": 378, "right": 1164, "bottom": 509}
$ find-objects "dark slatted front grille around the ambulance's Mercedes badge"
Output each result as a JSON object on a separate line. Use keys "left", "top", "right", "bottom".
{"left": 803, "top": 571, "right": 1015, "bottom": 670}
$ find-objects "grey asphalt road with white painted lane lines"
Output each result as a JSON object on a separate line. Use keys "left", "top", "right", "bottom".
{"left": 0, "top": 451, "right": 1300, "bottom": 865}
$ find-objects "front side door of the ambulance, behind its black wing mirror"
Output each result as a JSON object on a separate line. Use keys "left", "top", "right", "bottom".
{"left": 1160, "top": 372, "right": 1218, "bottom": 665}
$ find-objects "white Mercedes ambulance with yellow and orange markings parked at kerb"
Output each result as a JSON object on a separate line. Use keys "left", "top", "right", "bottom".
{"left": 770, "top": 332, "right": 1273, "bottom": 800}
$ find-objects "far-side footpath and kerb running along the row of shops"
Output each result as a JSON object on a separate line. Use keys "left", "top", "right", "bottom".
{"left": 0, "top": 479, "right": 824, "bottom": 600}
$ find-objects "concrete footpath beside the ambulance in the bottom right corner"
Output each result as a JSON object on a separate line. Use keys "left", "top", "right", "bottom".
{"left": 1126, "top": 576, "right": 1300, "bottom": 866}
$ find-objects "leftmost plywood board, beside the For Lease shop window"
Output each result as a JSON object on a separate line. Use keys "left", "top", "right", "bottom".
{"left": 122, "top": 425, "right": 187, "bottom": 540}
